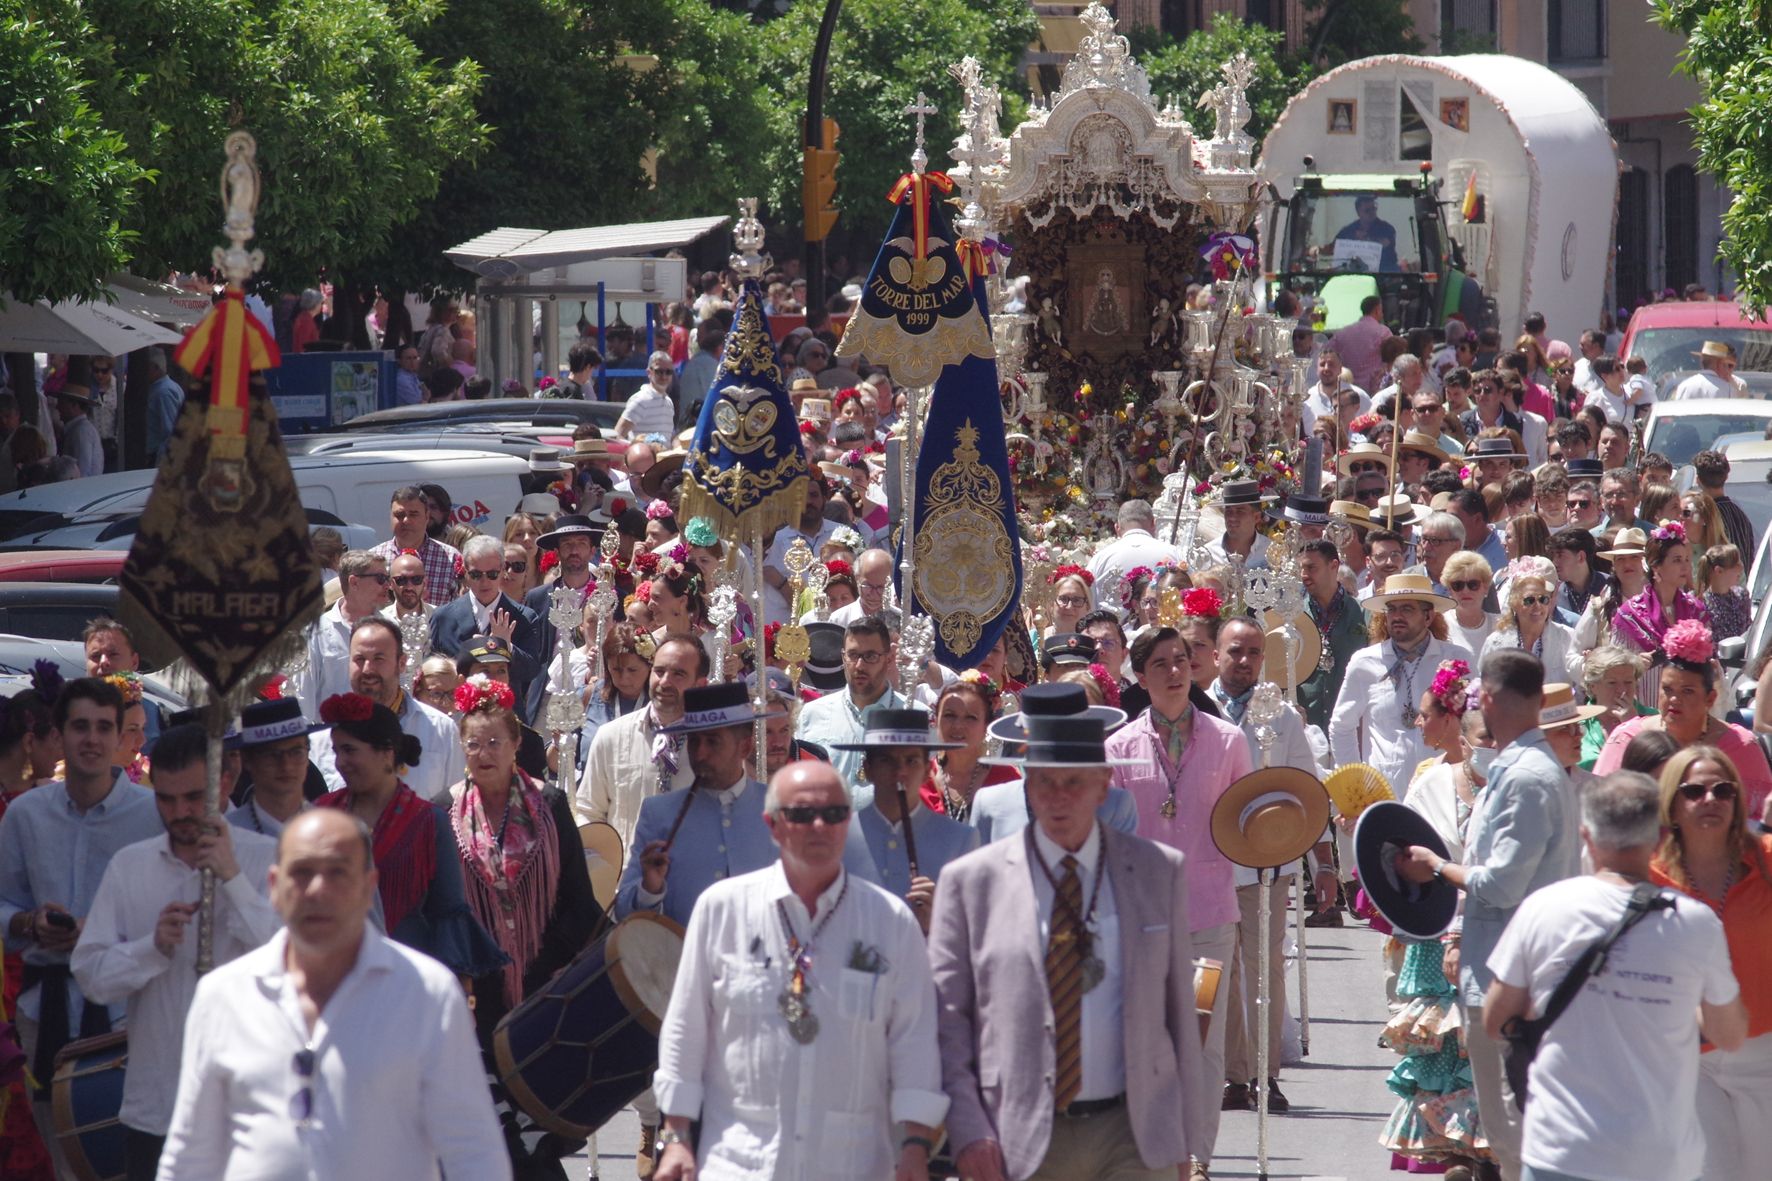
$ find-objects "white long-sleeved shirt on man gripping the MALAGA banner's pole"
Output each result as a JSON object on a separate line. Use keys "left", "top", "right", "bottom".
{"left": 69, "top": 830, "right": 282, "bottom": 1137}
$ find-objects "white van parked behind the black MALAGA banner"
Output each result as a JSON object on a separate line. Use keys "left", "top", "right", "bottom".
{"left": 0, "top": 449, "right": 530, "bottom": 541}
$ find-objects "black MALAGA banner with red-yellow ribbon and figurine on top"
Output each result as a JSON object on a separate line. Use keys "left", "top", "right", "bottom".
{"left": 117, "top": 131, "right": 323, "bottom": 697}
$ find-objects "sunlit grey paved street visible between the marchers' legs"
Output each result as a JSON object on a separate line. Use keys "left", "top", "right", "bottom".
{"left": 567, "top": 927, "right": 1396, "bottom": 1181}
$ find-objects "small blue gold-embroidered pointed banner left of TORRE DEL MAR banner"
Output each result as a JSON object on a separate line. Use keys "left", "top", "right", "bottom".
{"left": 679, "top": 278, "right": 810, "bottom": 531}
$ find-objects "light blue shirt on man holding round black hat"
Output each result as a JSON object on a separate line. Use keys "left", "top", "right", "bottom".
{"left": 1458, "top": 727, "right": 1581, "bottom": 1007}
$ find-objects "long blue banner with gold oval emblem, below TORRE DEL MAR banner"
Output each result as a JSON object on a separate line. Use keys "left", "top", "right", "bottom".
{"left": 911, "top": 264, "right": 1021, "bottom": 669}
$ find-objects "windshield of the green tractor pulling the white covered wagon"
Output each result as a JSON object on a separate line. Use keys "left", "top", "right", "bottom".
{"left": 1281, "top": 188, "right": 1441, "bottom": 273}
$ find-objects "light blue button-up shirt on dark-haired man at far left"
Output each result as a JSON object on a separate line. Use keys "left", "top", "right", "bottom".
{"left": 0, "top": 771, "right": 167, "bottom": 1037}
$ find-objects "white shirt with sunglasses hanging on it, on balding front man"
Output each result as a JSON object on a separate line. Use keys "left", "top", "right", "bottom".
{"left": 158, "top": 926, "right": 510, "bottom": 1181}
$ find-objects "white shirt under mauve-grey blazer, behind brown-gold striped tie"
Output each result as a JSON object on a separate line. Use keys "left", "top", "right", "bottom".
{"left": 1021, "top": 821, "right": 1125, "bottom": 1101}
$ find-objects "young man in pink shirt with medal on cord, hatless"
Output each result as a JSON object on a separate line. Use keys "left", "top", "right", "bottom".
{"left": 1108, "top": 628, "right": 1251, "bottom": 1177}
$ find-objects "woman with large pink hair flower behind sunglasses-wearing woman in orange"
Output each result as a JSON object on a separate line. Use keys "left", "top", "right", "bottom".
{"left": 1593, "top": 619, "right": 1772, "bottom": 819}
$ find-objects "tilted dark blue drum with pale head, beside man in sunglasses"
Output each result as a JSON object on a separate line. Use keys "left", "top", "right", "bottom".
{"left": 493, "top": 911, "right": 682, "bottom": 1138}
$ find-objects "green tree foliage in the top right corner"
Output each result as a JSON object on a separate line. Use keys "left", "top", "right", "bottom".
{"left": 1655, "top": 0, "right": 1772, "bottom": 314}
